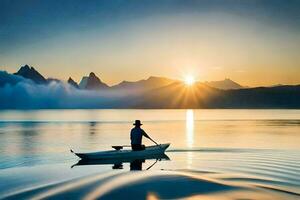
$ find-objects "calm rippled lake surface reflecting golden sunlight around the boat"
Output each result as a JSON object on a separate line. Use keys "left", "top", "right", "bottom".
{"left": 0, "top": 109, "right": 300, "bottom": 199}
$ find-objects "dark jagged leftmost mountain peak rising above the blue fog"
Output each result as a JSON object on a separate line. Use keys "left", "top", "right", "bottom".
{"left": 14, "top": 65, "right": 47, "bottom": 84}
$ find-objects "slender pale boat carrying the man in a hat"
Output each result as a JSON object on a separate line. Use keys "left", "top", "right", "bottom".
{"left": 71, "top": 143, "right": 170, "bottom": 160}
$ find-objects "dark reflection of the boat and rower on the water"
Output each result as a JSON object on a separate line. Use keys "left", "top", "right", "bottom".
{"left": 71, "top": 154, "right": 170, "bottom": 171}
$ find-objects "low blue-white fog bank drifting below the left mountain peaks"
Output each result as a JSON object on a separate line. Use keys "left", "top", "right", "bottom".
{"left": 0, "top": 71, "right": 129, "bottom": 109}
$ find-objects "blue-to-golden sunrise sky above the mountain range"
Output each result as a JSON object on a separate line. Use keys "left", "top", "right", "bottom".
{"left": 0, "top": 0, "right": 300, "bottom": 86}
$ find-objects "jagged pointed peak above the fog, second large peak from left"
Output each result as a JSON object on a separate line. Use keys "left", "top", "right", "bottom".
{"left": 79, "top": 72, "right": 109, "bottom": 90}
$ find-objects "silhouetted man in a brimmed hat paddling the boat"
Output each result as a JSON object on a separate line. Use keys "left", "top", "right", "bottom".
{"left": 130, "top": 120, "right": 152, "bottom": 151}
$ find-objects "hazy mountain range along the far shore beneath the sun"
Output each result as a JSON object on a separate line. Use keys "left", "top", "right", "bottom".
{"left": 0, "top": 65, "right": 300, "bottom": 108}
